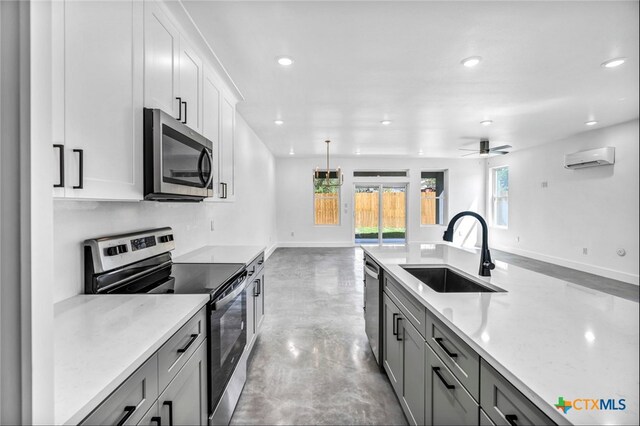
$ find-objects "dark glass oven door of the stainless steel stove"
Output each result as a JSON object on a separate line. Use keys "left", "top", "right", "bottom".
{"left": 209, "top": 291, "right": 247, "bottom": 409}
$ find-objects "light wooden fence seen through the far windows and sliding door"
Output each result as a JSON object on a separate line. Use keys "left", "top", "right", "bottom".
{"left": 315, "top": 192, "right": 437, "bottom": 228}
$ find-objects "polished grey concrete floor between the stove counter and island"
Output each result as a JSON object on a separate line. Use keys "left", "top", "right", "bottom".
{"left": 231, "top": 248, "right": 406, "bottom": 425}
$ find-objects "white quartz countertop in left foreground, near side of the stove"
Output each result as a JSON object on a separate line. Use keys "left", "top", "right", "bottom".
{"left": 54, "top": 294, "right": 209, "bottom": 424}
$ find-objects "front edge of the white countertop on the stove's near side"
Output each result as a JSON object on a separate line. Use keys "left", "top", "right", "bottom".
{"left": 54, "top": 299, "right": 208, "bottom": 425}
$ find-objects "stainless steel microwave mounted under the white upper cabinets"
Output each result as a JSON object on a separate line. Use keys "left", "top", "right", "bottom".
{"left": 144, "top": 108, "right": 214, "bottom": 201}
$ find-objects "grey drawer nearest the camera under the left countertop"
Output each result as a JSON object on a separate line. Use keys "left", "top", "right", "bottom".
{"left": 81, "top": 354, "right": 158, "bottom": 425}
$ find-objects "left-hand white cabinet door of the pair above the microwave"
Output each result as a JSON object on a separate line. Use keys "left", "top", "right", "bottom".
{"left": 144, "top": 1, "right": 182, "bottom": 118}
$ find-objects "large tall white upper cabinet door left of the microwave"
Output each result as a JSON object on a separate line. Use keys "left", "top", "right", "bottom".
{"left": 52, "top": 0, "right": 143, "bottom": 200}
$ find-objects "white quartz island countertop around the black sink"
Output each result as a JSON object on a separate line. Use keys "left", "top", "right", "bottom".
{"left": 363, "top": 244, "right": 640, "bottom": 425}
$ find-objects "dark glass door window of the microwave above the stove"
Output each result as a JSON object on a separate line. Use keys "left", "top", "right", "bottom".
{"left": 162, "top": 124, "right": 213, "bottom": 188}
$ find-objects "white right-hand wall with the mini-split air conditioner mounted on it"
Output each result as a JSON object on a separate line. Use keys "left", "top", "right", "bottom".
{"left": 488, "top": 120, "right": 639, "bottom": 284}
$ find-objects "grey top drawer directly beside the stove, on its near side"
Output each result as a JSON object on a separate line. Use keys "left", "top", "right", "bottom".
{"left": 158, "top": 308, "right": 207, "bottom": 392}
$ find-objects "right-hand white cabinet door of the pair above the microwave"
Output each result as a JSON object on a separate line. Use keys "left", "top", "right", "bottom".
{"left": 180, "top": 39, "right": 202, "bottom": 133}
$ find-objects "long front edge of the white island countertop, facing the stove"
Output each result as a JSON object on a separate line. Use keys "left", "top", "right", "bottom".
{"left": 361, "top": 246, "right": 573, "bottom": 425}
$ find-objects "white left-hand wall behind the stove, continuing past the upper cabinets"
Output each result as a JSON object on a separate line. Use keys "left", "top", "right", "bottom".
{"left": 54, "top": 114, "right": 276, "bottom": 302}
